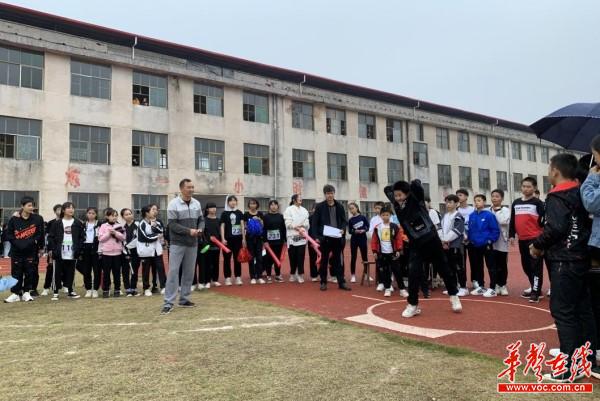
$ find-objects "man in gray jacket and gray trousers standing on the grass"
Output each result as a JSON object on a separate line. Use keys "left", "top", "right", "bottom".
{"left": 161, "top": 178, "right": 204, "bottom": 315}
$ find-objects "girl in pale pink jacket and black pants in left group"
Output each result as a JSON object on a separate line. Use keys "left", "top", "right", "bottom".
{"left": 98, "top": 207, "right": 125, "bottom": 298}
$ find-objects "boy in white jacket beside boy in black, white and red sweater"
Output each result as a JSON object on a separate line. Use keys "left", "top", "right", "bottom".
{"left": 490, "top": 189, "right": 510, "bottom": 296}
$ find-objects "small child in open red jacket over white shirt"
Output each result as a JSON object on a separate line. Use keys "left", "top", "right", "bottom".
{"left": 371, "top": 205, "right": 406, "bottom": 297}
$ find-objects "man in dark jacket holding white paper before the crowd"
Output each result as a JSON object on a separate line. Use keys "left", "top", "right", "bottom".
{"left": 315, "top": 185, "right": 351, "bottom": 291}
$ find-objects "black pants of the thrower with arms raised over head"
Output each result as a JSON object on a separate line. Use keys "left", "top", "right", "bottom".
{"left": 408, "top": 237, "right": 458, "bottom": 305}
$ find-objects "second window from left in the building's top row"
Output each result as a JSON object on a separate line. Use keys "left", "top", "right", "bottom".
{"left": 71, "top": 60, "right": 112, "bottom": 99}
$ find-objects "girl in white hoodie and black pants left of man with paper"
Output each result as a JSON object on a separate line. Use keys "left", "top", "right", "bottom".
{"left": 282, "top": 194, "right": 310, "bottom": 283}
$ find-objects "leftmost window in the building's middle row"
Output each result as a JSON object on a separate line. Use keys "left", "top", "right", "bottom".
{"left": 0, "top": 116, "right": 42, "bottom": 160}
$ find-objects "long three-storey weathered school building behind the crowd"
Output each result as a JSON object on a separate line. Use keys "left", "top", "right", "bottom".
{"left": 0, "top": 4, "right": 559, "bottom": 222}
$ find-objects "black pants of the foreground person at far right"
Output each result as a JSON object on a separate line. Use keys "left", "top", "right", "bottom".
{"left": 549, "top": 261, "right": 598, "bottom": 366}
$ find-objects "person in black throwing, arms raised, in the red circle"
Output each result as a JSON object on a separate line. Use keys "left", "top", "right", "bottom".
{"left": 384, "top": 180, "right": 462, "bottom": 318}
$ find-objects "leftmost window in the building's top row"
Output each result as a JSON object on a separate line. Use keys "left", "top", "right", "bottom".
{"left": 0, "top": 46, "right": 44, "bottom": 89}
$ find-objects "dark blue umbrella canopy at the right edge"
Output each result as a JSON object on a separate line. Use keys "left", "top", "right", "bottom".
{"left": 531, "top": 103, "right": 600, "bottom": 152}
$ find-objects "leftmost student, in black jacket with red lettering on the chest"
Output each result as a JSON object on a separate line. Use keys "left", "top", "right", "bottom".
{"left": 4, "top": 196, "right": 44, "bottom": 303}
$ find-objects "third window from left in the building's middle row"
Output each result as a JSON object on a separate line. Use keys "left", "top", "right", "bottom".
{"left": 131, "top": 131, "right": 168, "bottom": 168}
